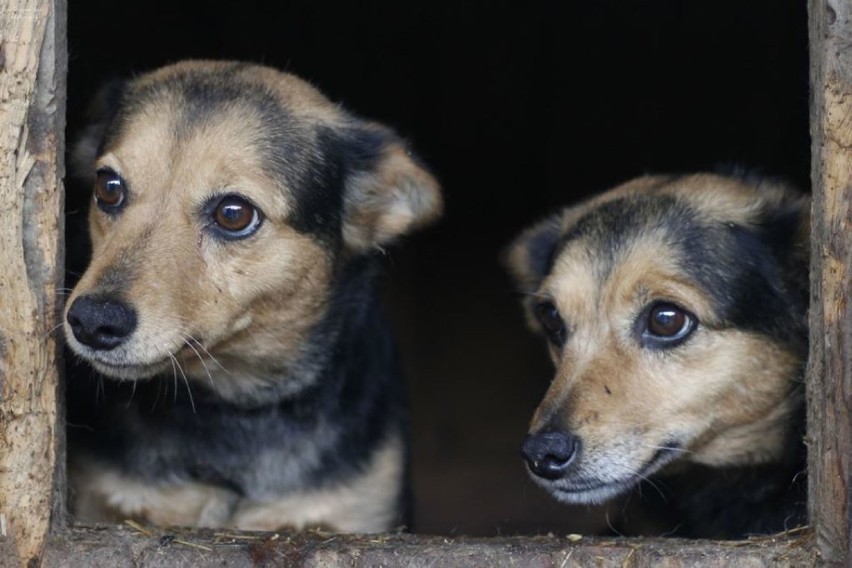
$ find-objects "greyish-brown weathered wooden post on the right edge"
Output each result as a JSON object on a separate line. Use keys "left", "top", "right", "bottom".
{"left": 808, "top": 0, "right": 852, "bottom": 566}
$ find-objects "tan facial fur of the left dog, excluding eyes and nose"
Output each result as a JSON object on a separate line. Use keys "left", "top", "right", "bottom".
{"left": 68, "top": 94, "right": 330, "bottom": 397}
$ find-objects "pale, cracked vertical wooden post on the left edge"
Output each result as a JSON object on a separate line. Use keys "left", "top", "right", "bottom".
{"left": 0, "top": 0, "right": 66, "bottom": 565}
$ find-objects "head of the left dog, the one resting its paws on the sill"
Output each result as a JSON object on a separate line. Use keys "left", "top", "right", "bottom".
{"left": 65, "top": 61, "right": 441, "bottom": 402}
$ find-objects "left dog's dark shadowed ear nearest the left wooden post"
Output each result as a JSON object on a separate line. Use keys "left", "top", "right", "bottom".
{"left": 70, "top": 79, "right": 127, "bottom": 182}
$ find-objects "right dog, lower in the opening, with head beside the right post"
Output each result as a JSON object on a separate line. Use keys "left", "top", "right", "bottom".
{"left": 505, "top": 174, "right": 810, "bottom": 538}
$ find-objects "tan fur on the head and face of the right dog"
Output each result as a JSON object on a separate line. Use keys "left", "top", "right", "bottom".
{"left": 507, "top": 175, "right": 801, "bottom": 502}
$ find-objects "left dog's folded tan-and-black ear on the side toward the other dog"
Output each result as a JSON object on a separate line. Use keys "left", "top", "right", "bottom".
{"left": 343, "top": 123, "right": 443, "bottom": 252}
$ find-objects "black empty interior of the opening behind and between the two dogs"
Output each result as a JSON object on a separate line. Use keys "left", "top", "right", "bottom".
{"left": 68, "top": 0, "right": 810, "bottom": 535}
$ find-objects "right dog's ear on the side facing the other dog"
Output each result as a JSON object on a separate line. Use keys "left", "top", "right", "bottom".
{"left": 503, "top": 214, "right": 562, "bottom": 292}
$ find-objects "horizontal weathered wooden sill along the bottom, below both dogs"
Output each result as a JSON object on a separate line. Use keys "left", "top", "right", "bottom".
{"left": 36, "top": 527, "right": 816, "bottom": 568}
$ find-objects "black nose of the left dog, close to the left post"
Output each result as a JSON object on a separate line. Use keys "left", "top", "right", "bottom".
{"left": 66, "top": 296, "right": 136, "bottom": 351}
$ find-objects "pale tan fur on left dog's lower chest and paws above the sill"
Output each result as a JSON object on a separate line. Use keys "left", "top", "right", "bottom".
{"left": 72, "top": 438, "right": 403, "bottom": 533}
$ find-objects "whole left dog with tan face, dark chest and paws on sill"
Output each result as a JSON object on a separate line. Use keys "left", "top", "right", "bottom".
{"left": 64, "top": 61, "right": 442, "bottom": 532}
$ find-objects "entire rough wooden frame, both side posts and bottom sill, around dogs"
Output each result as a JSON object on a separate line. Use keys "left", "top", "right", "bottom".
{"left": 0, "top": 0, "right": 852, "bottom": 567}
